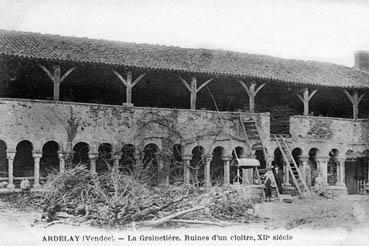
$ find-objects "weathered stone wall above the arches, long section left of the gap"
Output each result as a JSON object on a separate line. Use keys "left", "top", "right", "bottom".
{"left": 0, "top": 99, "right": 270, "bottom": 155}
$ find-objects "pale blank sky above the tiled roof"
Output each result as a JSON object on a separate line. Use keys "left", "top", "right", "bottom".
{"left": 0, "top": 0, "right": 369, "bottom": 67}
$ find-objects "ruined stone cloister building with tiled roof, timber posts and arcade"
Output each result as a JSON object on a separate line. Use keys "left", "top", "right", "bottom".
{"left": 0, "top": 30, "right": 369, "bottom": 194}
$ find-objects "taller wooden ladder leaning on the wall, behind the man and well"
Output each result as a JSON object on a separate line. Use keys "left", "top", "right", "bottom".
{"left": 240, "top": 115, "right": 280, "bottom": 197}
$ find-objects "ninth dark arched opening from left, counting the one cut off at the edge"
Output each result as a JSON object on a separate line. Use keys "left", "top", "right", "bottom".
{"left": 190, "top": 146, "right": 206, "bottom": 186}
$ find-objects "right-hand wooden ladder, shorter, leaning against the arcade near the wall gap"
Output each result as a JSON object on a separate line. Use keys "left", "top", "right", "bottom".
{"left": 274, "top": 135, "right": 310, "bottom": 196}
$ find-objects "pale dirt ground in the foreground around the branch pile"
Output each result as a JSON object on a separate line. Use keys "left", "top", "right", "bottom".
{"left": 0, "top": 195, "right": 369, "bottom": 246}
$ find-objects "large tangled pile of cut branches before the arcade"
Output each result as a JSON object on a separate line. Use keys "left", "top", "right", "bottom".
{"left": 32, "top": 165, "right": 259, "bottom": 226}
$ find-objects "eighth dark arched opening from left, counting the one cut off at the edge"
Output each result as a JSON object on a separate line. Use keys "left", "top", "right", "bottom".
{"left": 169, "top": 144, "right": 184, "bottom": 184}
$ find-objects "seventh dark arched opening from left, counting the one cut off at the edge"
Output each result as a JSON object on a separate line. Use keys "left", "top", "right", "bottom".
{"left": 143, "top": 143, "right": 159, "bottom": 185}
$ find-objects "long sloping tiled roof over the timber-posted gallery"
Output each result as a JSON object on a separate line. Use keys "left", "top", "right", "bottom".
{"left": 0, "top": 30, "right": 369, "bottom": 88}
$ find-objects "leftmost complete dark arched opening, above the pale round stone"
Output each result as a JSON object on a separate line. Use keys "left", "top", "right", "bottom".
{"left": 13, "top": 140, "right": 35, "bottom": 177}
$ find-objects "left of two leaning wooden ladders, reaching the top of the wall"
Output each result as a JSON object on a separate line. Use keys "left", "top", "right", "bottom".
{"left": 240, "top": 115, "right": 279, "bottom": 197}
